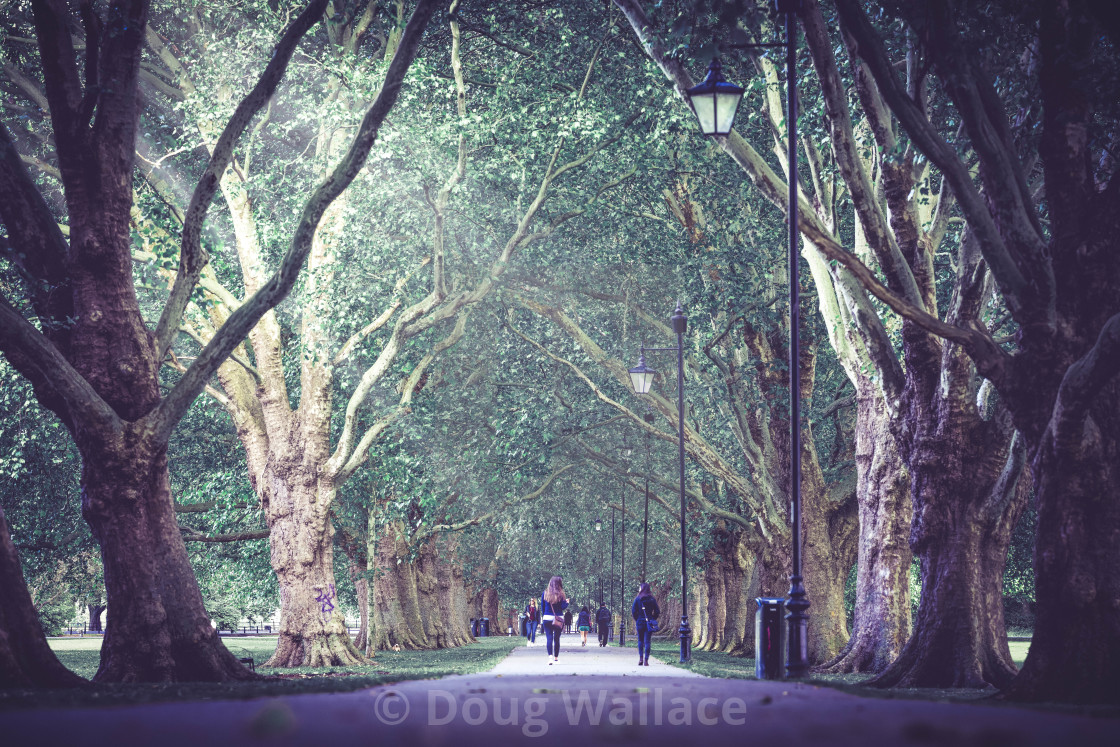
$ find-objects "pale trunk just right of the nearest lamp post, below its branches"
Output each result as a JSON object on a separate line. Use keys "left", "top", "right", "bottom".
{"left": 816, "top": 389, "right": 913, "bottom": 674}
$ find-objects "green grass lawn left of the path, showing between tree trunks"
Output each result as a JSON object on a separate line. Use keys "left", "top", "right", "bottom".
{"left": 0, "top": 636, "right": 524, "bottom": 709}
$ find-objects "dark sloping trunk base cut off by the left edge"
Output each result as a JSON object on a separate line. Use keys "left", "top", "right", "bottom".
{"left": 0, "top": 506, "right": 85, "bottom": 688}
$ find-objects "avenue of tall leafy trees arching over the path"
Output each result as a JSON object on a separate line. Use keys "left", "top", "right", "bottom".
{"left": 0, "top": 0, "right": 1120, "bottom": 702}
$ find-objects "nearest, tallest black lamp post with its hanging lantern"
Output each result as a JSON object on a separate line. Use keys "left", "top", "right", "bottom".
{"left": 685, "top": 0, "right": 809, "bottom": 678}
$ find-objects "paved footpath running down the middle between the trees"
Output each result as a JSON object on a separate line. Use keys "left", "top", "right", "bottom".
{"left": 0, "top": 636, "right": 1120, "bottom": 747}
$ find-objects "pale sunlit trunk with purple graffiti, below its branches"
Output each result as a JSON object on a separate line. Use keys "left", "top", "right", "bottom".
{"left": 264, "top": 470, "right": 365, "bottom": 666}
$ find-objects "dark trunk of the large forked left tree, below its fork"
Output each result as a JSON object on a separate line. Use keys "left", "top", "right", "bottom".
{"left": 78, "top": 443, "right": 255, "bottom": 682}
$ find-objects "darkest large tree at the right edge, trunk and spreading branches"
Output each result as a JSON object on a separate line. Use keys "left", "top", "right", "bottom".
{"left": 837, "top": 0, "right": 1120, "bottom": 702}
